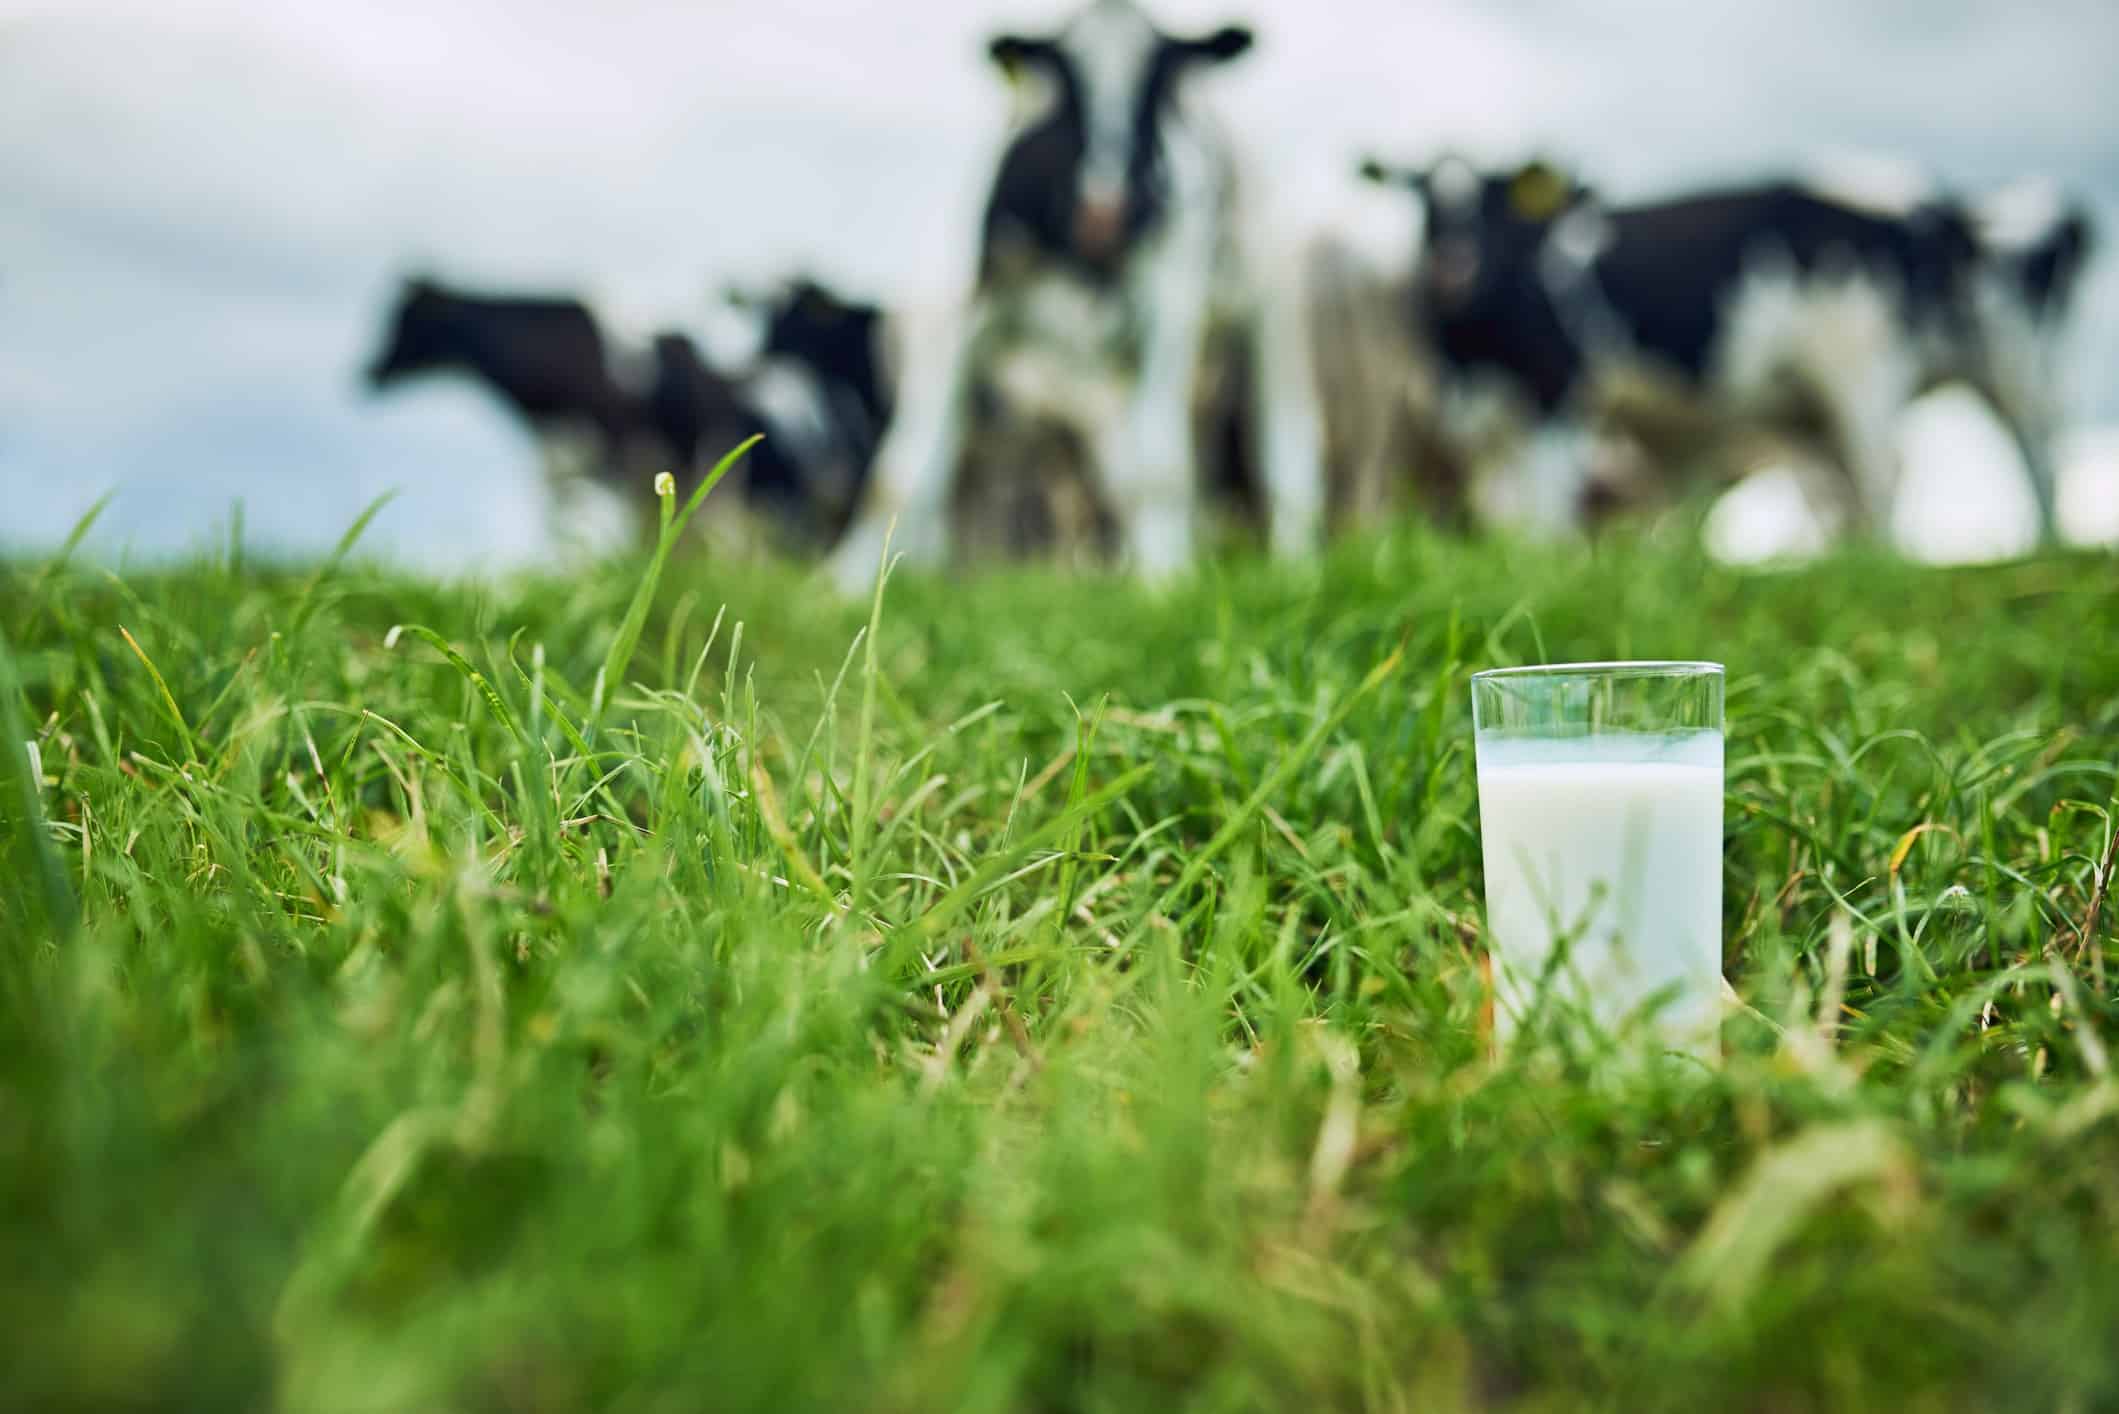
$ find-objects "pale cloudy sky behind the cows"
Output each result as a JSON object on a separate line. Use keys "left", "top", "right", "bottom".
{"left": 0, "top": 0, "right": 2119, "bottom": 570}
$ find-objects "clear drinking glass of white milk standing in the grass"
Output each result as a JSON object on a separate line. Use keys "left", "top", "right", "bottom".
{"left": 1471, "top": 664, "right": 1723, "bottom": 1062}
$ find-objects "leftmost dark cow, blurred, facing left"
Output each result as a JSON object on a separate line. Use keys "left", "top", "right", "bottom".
{"left": 367, "top": 278, "right": 807, "bottom": 534}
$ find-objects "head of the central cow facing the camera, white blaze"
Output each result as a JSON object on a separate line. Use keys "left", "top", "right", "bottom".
{"left": 990, "top": 0, "right": 1252, "bottom": 271}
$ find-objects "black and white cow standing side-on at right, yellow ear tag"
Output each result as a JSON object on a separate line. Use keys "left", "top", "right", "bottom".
{"left": 1365, "top": 161, "right": 2076, "bottom": 532}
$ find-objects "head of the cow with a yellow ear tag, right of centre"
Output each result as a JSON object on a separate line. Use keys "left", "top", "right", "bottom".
{"left": 1360, "top": 157, "right": 1600, "bottom": 318}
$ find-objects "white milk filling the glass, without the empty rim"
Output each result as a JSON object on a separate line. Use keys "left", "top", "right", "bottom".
{"left": 1479, "top": 731, "right": 1723, "bottom": 1060}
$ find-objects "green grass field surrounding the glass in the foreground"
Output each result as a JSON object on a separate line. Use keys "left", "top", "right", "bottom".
{"left": 0, "top": 517, "right": 2119, "bottom": 1412}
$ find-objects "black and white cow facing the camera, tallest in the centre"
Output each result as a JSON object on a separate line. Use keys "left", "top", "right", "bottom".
{"left": 833, "top": 0, "right": 1322, "bottom": 591}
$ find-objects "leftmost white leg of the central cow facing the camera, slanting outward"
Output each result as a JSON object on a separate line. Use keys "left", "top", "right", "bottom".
{"left": 829, "top": 312, "right": 985, "bottom": 594}
